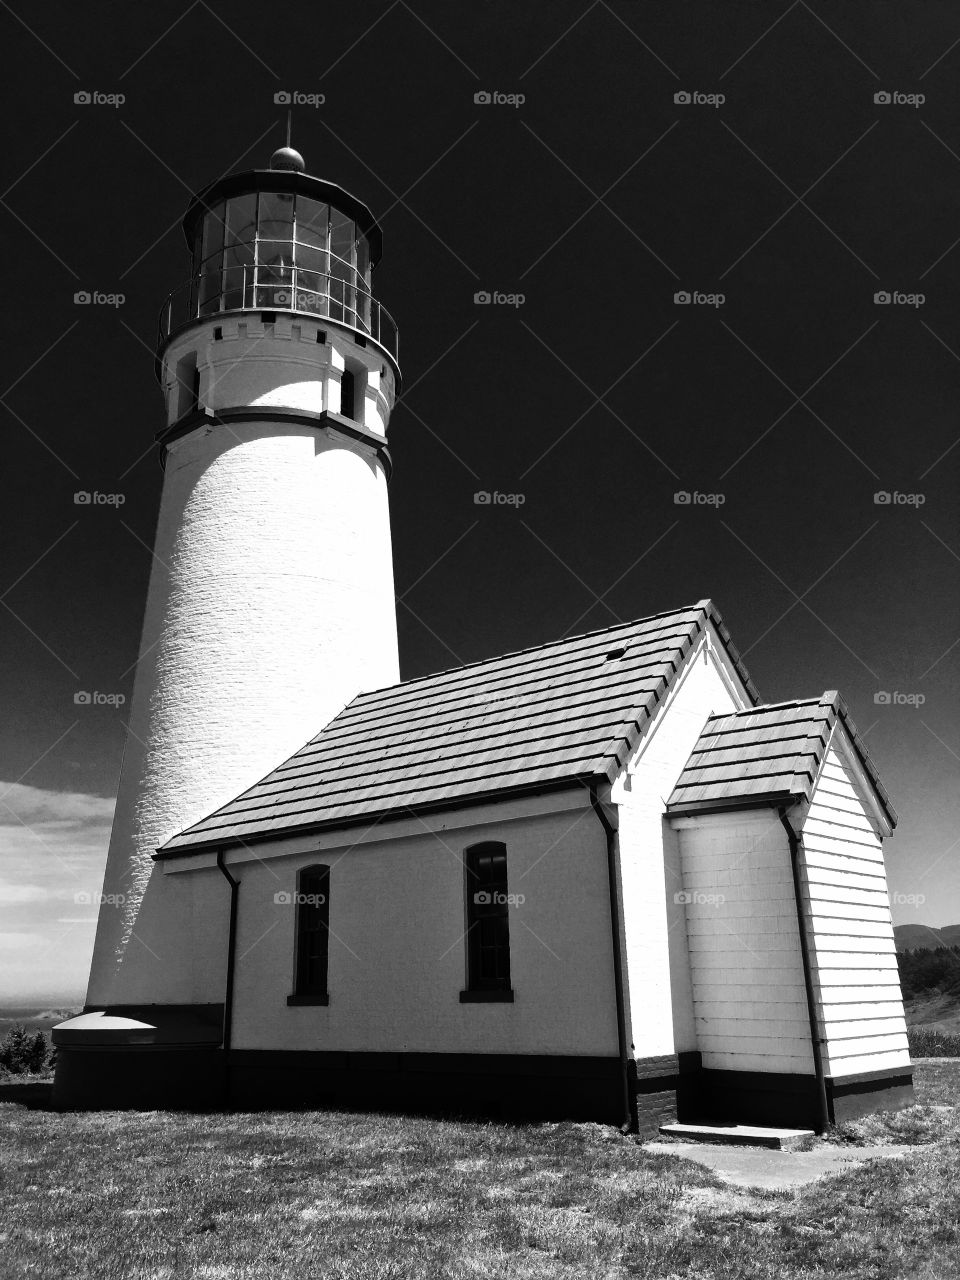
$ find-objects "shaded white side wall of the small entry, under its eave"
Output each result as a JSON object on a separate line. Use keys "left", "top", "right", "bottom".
{"left": 678, "top": 812, "right": 813, "bottom": 1074}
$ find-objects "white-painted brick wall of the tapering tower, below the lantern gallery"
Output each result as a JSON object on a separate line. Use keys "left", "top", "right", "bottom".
{"left": 87, "top": 320, "right": 399, "bottom": 1004}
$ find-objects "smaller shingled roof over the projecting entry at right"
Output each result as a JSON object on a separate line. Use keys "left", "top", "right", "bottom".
{"left": 667, "top": 691, "right": 897, "bottom": 826}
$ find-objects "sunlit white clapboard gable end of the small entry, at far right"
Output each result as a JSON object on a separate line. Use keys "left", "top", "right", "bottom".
{"left": 801, "top": 730, "right": 910, "bottom": 1076}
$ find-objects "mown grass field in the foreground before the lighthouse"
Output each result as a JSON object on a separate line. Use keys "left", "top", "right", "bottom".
{"left": 0, "top": 1061, "right": 960, "bottom": 1280}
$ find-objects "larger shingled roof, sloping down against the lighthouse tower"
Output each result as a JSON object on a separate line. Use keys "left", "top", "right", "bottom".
{"left": 157, "top": 600, "right": 759, "bottom": 858}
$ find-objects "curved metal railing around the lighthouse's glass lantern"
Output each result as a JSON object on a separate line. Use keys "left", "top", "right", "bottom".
{"left": 157, "top": 264, "right": 398, "bottom": 361}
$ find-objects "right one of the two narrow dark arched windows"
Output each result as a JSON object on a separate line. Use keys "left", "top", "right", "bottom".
{"left": 460, "top": 841, "right": 513, "bottom": 1004}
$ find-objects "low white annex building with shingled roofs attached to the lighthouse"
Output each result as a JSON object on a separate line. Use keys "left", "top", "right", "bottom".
{"left": 58, "top": 600, "right": 913, "bottom": 1132}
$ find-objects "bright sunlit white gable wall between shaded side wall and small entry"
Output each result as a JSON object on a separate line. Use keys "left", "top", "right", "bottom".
{"left": 612, "top": 627, "right": 750, "bottom": 1057}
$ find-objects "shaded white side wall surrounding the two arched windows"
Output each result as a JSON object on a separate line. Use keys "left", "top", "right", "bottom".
{"left": 211, "top": 790, "right": 617, "bottom": 1055}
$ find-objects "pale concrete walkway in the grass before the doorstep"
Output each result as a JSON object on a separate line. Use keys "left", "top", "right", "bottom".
{"left": 644, "top": 1142, "right": 922, "bottom": 1192}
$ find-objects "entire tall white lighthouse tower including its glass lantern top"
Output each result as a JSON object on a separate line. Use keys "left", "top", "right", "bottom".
{"left": 87, "top": 146, "right": 399, "bottom": 1010}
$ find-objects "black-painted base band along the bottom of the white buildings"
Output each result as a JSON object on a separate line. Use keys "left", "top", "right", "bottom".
{"left": 54, "top": 1039, "right": 914, "bottom": 1137}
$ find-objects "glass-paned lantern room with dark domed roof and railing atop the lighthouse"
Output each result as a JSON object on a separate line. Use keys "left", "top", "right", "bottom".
{"left": 159, "top": 147, "right": 399, "bottom": 372}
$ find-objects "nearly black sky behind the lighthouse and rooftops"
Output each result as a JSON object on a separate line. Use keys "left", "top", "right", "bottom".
{"left": 0, "top": 0, "right": 960, "bottom": 998}
